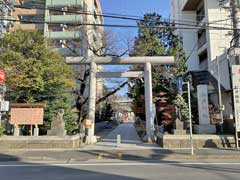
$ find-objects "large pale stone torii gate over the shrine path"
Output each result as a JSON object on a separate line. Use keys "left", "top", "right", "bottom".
{"left": 67, "top": 56, "right": 174, "bottom": 144}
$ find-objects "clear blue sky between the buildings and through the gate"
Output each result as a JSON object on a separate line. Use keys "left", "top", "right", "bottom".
{"left": 100, "top": 0, "right": 170, "bottom": 95}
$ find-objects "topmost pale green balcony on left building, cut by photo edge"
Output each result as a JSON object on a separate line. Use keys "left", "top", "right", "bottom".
{"left": 46, "top": 0, "right": 83, "bottom": 8}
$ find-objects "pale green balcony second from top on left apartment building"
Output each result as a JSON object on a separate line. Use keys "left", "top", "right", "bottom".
{"left": 45, "top": 15, "right": 83, "bottom": 24}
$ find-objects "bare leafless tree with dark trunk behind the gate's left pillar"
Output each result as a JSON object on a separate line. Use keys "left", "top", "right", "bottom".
{"left": 63, "top": 30, "right": 134, "bottom": 132}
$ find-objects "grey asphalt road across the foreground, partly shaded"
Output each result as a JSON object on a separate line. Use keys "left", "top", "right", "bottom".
{"left": 0, "top": 162, "right": 240, "bottom": 180}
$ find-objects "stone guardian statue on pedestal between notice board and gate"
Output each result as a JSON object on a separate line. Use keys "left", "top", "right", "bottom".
{"left": 47, "top": 109, "right": 66, "bottom": 136}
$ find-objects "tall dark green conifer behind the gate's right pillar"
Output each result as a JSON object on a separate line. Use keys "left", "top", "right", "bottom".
{"left": 131, "top": 13, "right": 187, "bottom": 124}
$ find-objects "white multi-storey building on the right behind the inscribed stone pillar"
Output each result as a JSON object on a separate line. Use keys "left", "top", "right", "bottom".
{"left": 171, "top": 0, "right": 236, "bottom": 134}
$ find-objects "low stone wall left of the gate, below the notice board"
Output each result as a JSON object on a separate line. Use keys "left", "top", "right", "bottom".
{"left": 0, "top": 135, "right": 81, "bottom": 150}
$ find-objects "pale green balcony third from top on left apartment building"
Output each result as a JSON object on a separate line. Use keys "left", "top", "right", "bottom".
{"left": 45, "top": 31, "right": 82, "bottom": 40}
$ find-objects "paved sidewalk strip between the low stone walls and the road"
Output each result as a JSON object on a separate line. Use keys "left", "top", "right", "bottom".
{"left": 0, "top": 149, "right": 240, "bottom": 163}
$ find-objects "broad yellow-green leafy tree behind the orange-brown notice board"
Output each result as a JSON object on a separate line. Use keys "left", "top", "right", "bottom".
{"left": 0, "top": 30, "right": 76, "bottom": 132}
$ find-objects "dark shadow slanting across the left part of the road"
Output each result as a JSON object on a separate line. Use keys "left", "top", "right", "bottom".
{"left": 0, "top": 154, "right": 142, "bottom": 180}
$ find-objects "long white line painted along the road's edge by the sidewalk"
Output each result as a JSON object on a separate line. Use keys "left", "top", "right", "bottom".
{"left": 0, "top": 162, "right": 240, "bottom": 168}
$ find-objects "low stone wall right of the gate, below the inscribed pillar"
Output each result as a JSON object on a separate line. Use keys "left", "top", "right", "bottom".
{"left": 157, "top": 134, "right": 236, "bottom": 148}
